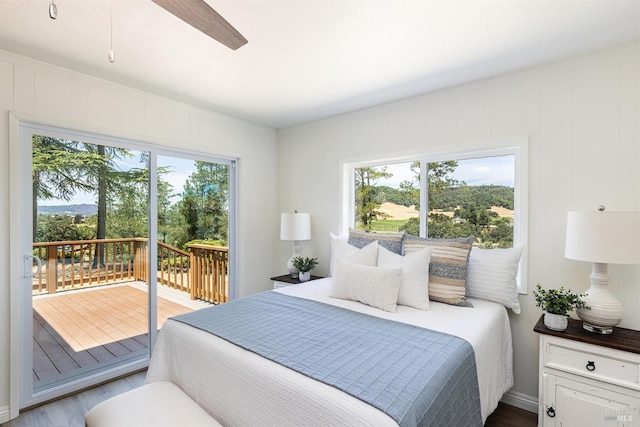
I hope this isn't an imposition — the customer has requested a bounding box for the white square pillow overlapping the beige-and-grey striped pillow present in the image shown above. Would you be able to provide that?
[378,246,432,310]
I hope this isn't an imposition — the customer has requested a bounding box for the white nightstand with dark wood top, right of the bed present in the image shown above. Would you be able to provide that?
[533,315,640,427]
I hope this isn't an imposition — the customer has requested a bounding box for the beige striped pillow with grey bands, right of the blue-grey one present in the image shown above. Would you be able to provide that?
[404,234,475,307]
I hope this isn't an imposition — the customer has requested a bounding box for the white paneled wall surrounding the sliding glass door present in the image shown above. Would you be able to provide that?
[0,51,279,422]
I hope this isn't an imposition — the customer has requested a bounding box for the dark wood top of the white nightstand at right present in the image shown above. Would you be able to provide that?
[533,314,640,354]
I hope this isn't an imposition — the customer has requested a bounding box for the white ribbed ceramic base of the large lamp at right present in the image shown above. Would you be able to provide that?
[576,262,624,335]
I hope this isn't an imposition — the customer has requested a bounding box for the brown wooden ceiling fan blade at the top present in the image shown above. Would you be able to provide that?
[152,0,247,50]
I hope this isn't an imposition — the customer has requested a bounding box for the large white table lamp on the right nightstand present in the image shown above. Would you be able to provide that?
[564,206,640,334]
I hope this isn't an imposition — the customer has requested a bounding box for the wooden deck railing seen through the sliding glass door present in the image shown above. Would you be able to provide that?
[33,238,229,303]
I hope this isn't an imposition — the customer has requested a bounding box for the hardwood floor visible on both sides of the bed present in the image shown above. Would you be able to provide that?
[0,371,538,427]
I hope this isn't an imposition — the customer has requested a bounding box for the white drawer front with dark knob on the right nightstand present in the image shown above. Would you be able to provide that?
[544,340,640,388]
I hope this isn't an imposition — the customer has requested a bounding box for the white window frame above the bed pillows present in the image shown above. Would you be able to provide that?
[338,136,529,294]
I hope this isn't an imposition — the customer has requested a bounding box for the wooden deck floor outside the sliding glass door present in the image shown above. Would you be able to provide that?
[33,283,209,388]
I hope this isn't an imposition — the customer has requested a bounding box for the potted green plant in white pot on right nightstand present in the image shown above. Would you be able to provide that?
[533,283,590,331]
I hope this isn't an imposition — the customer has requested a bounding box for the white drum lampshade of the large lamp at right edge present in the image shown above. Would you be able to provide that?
[564,211,640,264]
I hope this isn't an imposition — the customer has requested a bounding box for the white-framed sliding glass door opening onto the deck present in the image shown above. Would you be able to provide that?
[17,124,234,408]
